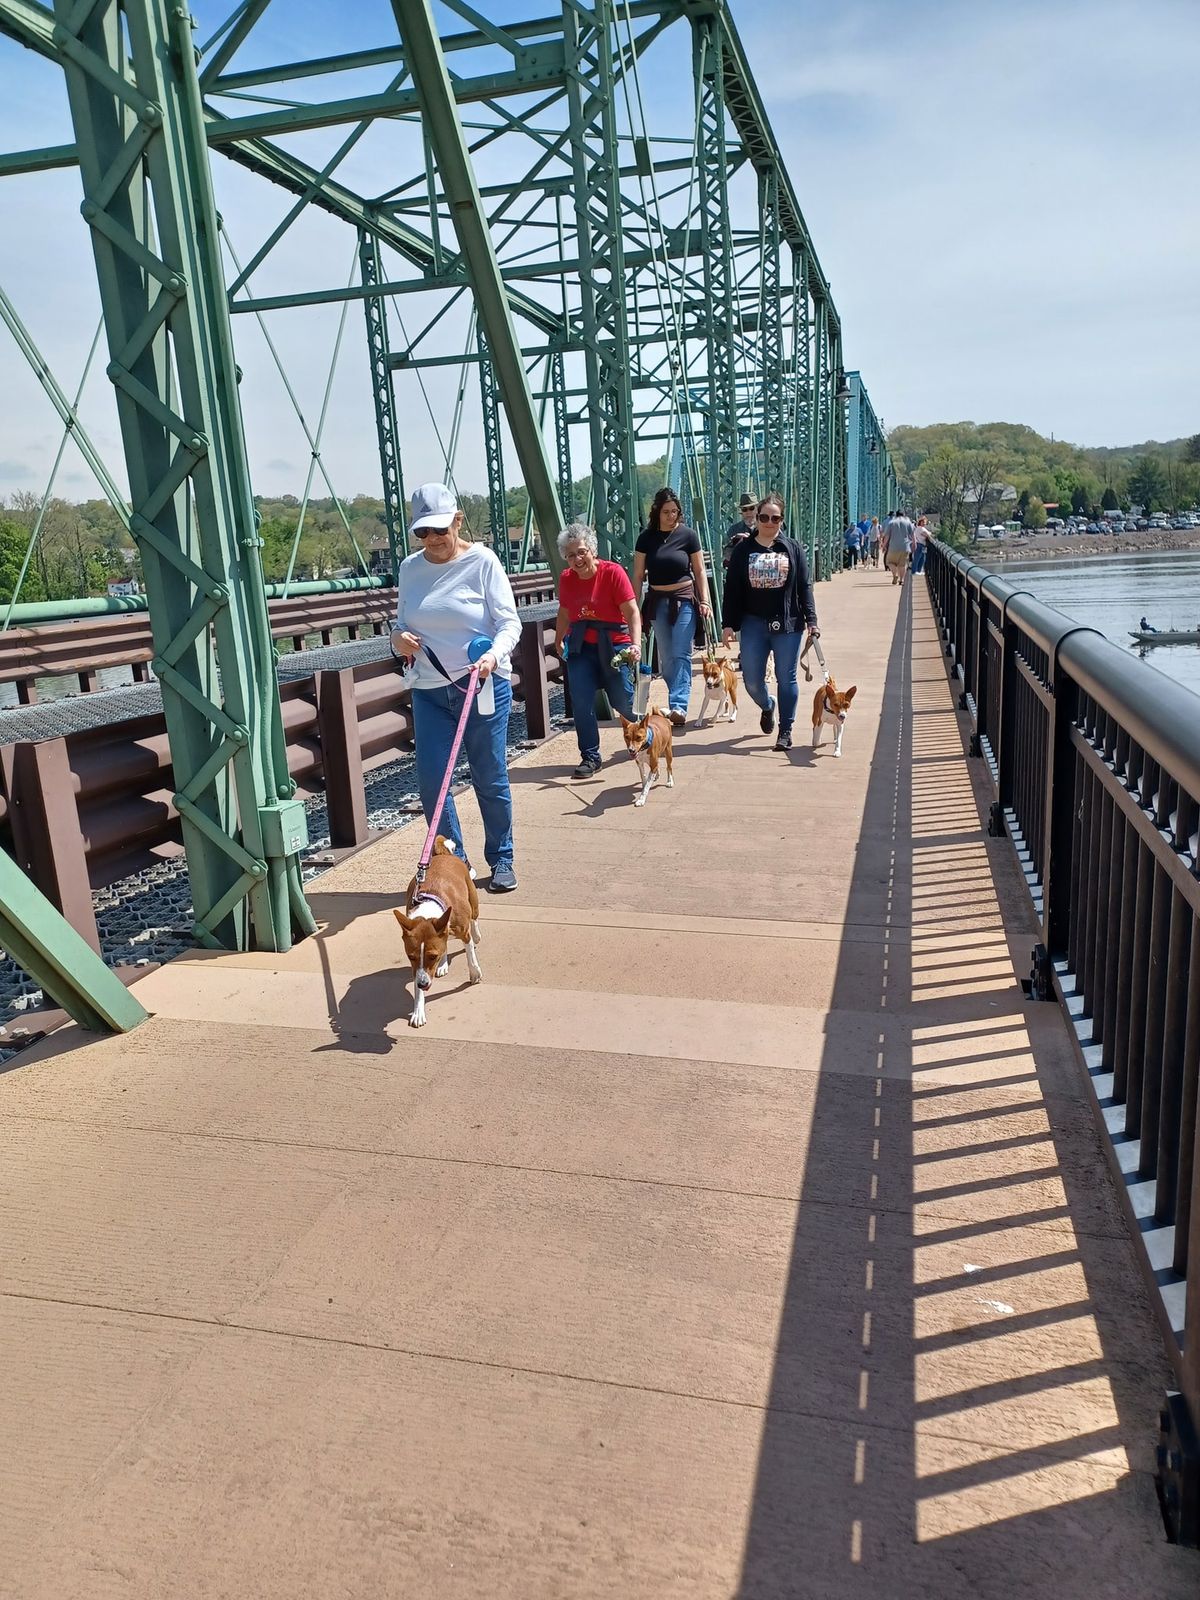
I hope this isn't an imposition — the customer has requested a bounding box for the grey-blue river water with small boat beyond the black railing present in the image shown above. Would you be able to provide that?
[984,550,1200,694]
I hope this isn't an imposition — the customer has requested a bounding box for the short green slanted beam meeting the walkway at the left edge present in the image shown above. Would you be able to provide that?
[0,850,146,1034]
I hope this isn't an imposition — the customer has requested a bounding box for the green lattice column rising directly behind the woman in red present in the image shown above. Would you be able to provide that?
[563,0,638,562]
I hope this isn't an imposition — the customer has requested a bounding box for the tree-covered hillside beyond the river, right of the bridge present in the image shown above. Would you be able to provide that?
[888,422,1200,541]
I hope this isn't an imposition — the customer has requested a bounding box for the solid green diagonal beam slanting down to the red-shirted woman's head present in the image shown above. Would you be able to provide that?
[392,0,562,573]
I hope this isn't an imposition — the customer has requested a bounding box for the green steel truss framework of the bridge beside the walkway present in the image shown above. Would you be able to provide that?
[0,0,894,992]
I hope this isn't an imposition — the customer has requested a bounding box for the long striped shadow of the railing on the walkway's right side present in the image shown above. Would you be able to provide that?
[736,586,1195,1600]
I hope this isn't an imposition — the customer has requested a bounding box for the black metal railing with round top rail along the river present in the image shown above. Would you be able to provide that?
[926,542,1200,1544]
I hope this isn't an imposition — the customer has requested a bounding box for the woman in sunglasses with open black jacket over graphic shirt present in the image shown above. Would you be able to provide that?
[722,494,819,750]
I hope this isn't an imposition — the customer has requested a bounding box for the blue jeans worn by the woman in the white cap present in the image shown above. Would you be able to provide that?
[413,674,512,872]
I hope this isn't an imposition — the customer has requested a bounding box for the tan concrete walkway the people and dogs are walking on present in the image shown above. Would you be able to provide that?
[0,573,1200,1600]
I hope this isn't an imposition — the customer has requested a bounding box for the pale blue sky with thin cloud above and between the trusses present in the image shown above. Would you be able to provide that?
[0,0,1200,498]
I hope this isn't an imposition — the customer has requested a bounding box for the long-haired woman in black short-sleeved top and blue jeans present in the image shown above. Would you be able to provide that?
[634,490,712,728]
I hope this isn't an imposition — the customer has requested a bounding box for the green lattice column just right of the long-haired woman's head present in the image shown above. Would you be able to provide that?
[691,16,741,538]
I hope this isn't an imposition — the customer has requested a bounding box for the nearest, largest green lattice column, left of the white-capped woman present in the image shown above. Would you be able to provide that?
[54,0,314,949]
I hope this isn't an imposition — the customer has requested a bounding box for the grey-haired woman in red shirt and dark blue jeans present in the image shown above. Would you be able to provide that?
[554,522,642,778]
